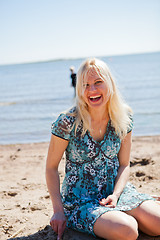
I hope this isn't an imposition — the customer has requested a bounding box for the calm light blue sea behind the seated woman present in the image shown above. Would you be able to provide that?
[0,52,160,144]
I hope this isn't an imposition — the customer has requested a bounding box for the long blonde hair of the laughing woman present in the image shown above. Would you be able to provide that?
[68,58,132,139]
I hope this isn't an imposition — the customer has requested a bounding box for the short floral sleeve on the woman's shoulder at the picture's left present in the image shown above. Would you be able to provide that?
[51,114,74,140]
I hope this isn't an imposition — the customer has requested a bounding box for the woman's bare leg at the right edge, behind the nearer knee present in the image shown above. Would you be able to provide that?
[127,200,160,236]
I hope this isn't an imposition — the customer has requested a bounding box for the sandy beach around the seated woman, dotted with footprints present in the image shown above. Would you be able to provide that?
[0,136,160,240]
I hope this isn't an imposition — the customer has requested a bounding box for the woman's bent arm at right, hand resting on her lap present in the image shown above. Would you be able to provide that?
[100,132,132,207]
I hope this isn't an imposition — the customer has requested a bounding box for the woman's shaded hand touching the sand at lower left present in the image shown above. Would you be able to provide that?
[50,212,66,240]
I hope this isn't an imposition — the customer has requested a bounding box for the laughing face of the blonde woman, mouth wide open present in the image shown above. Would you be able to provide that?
[83,70,109,109]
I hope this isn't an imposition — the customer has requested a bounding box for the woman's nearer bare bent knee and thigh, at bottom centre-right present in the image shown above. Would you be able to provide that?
[94,211,138,240]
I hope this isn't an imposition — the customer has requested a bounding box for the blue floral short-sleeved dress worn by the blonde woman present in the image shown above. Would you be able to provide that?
[52,110,153,236]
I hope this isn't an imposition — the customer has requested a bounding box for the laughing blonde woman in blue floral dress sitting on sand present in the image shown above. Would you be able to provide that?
[46,58,160,240]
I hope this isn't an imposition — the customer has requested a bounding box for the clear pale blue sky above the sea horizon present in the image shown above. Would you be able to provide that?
[0,0,160,64]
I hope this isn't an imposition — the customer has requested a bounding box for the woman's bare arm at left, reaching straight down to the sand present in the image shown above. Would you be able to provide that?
[46,135,68,238]
